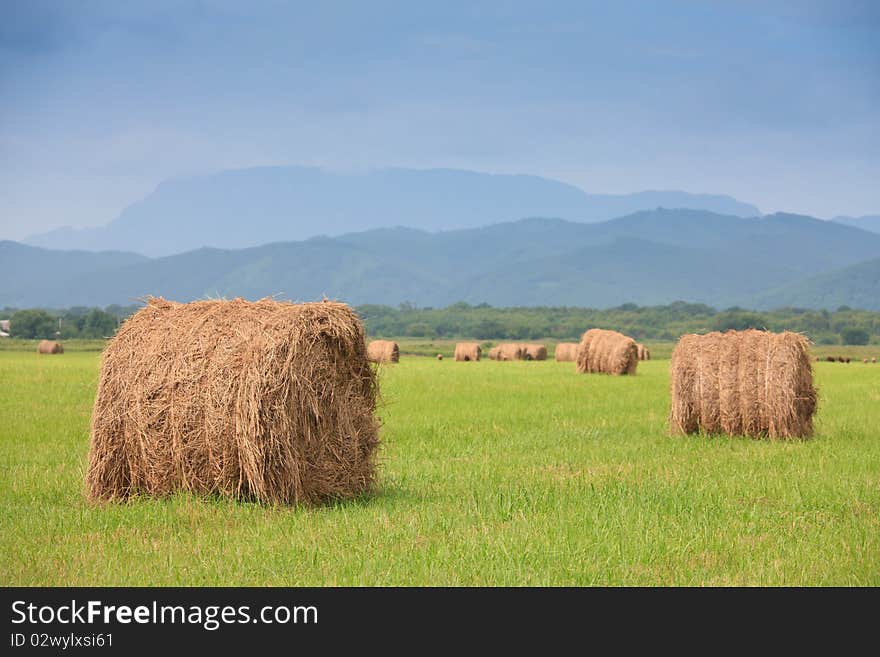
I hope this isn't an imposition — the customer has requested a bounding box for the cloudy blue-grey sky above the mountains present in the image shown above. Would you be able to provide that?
[0,0,880,239]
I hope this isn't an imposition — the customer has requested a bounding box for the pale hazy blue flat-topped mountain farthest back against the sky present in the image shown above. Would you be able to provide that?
[24,167,760,257]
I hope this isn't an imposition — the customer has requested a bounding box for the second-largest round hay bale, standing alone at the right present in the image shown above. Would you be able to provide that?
[669,330,816,438]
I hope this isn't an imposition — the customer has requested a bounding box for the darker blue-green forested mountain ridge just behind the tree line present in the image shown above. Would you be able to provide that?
[6,209,880,310]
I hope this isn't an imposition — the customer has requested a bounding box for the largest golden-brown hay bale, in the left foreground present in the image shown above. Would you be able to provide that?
[86,298,378,504]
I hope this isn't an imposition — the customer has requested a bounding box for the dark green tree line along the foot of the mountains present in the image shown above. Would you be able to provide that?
[0,301,880,345]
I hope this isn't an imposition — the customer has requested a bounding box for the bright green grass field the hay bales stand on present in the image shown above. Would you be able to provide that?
[0,351,880,585]
